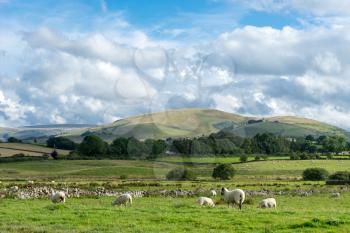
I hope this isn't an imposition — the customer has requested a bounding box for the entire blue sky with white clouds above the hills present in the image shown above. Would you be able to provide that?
[0,0,350,130]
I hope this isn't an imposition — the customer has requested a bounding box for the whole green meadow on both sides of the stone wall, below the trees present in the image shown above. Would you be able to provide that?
[0,157,350,233]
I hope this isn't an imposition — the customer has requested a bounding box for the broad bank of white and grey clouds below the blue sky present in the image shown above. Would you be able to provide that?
[0,10,350,129]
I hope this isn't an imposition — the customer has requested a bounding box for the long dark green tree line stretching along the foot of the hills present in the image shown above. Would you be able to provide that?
[47,131,350,159]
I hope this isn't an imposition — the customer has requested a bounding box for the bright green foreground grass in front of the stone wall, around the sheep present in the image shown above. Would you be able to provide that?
[0,194,350,233]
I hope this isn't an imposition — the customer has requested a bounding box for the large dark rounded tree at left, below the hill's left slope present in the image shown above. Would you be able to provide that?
[78,135,107,157]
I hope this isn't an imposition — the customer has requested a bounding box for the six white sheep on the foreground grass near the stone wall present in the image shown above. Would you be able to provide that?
[50,188,284,209]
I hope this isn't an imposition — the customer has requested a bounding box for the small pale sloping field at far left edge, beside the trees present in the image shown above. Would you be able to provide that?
[0,143,69,157]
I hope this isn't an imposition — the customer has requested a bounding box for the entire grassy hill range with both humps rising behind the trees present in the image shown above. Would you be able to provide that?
[66,109,350,141]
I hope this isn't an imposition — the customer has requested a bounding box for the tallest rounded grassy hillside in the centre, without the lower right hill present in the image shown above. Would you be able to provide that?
[65,109,249,140]
